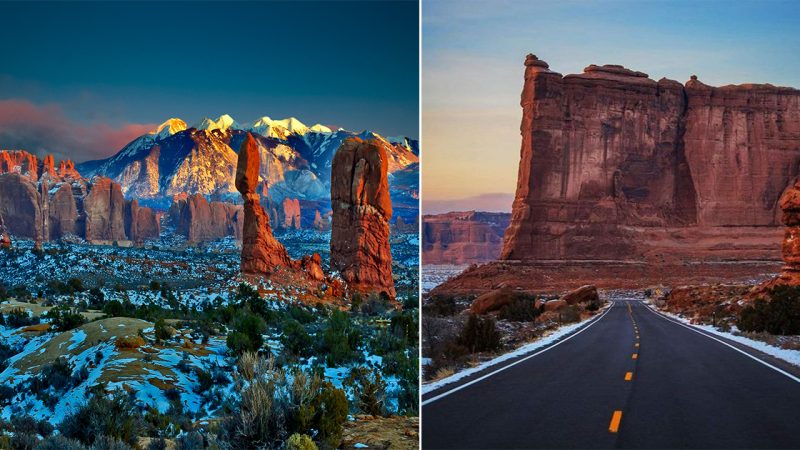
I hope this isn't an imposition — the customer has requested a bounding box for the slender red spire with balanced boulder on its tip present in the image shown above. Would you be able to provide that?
[236,133,292,275]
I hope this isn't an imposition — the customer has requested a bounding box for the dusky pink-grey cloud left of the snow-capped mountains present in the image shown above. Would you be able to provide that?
[0,99,156,162]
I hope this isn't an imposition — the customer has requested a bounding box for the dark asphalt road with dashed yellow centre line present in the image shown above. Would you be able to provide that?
[422,300,800,449]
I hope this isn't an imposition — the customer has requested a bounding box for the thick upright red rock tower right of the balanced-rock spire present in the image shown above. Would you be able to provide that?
[331,138,396,298]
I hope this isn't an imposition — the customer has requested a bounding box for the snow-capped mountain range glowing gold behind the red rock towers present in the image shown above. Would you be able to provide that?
[76,114,419,206]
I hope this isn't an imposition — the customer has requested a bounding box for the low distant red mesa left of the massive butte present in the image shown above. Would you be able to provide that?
[422,211,511,264]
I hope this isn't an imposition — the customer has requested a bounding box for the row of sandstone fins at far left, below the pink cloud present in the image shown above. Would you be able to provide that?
[0,150,160,243]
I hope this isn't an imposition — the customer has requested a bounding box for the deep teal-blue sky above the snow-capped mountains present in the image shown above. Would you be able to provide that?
[0,1,419,159]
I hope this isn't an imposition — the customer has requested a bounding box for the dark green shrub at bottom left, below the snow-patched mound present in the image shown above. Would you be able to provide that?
[58,393,145,449]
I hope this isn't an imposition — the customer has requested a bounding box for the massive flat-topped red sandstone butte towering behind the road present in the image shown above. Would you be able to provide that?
[501,55,800,261]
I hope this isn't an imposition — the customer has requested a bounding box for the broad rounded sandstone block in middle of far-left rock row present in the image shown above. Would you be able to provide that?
[83,177,126,241]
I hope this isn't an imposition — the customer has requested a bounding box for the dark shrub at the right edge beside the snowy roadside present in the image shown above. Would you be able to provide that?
[736,286,800,335]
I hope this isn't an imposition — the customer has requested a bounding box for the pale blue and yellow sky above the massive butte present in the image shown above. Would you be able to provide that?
[422,0,800,210]
